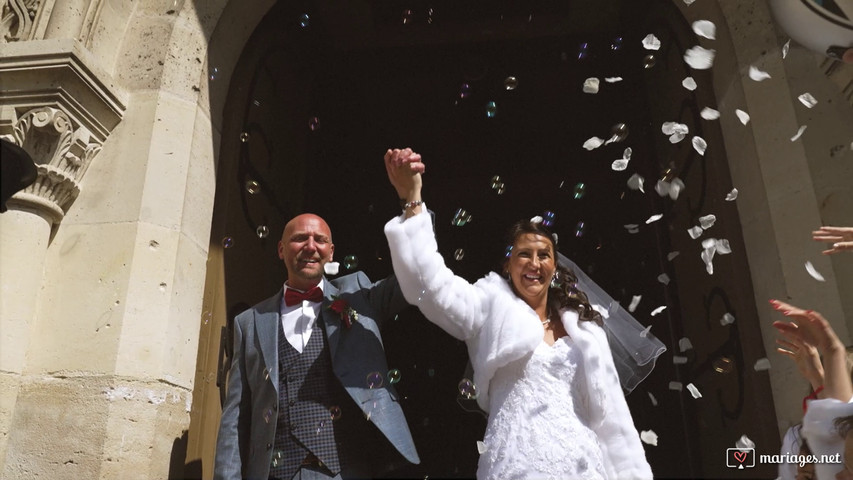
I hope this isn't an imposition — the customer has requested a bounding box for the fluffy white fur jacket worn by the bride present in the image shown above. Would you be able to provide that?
[385,207,652,479]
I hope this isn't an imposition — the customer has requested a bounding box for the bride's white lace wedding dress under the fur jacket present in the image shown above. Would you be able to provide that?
[477,337,606,480]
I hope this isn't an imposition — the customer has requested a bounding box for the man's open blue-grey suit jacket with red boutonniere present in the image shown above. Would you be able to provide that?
[214,272,420,480]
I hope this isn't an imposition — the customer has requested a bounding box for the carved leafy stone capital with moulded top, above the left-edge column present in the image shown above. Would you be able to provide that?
[0,41,126,224]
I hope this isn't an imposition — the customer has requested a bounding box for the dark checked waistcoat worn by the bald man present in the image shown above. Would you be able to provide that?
[270,319,368,479]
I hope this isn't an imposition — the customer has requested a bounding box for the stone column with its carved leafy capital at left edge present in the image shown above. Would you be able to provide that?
[0,40,124,468]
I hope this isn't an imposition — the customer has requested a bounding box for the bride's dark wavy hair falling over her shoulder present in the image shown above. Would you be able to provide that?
[503,220,603,325]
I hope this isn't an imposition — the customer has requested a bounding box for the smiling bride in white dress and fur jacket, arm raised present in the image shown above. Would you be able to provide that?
[385,149,662,480]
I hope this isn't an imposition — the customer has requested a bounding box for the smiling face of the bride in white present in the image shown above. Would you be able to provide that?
[506,233,557,309]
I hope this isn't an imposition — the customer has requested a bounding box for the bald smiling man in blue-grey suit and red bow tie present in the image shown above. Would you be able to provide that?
[214,214,420,480]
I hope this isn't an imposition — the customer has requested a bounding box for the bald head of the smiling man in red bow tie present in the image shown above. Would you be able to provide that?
[278,214,335,290]
